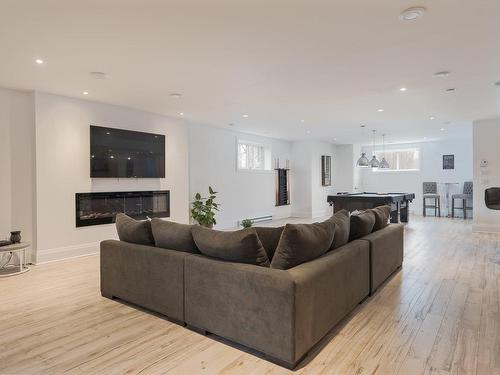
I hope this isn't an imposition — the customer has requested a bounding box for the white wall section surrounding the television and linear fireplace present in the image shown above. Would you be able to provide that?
[35,93,189,262]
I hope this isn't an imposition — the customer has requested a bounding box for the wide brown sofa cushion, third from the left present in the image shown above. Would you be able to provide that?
[192,225,269,267]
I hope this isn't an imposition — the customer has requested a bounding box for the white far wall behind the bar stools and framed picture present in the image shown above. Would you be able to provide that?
[356,137,472,215]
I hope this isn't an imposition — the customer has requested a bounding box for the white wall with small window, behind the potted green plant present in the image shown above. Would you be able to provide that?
[189,124,294,228]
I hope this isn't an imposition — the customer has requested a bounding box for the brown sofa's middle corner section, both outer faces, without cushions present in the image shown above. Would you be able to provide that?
[185,241,369,368]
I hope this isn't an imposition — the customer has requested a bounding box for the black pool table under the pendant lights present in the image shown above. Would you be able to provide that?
[327,192,415,223]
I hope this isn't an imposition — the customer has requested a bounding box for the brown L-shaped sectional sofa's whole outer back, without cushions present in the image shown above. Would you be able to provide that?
[101,224,403,368]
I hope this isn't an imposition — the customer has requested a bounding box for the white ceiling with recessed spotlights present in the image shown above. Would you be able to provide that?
[0,0,500,143]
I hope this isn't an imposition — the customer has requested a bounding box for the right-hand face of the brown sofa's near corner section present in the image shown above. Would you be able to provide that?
[288,240,370,358]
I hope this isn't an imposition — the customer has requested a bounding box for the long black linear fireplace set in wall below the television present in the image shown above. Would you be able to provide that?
[75,190,170,227]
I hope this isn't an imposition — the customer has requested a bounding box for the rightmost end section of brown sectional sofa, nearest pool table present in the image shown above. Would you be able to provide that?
[361,224,404,294]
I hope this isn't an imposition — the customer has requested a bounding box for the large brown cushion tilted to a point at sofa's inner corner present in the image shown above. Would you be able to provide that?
[271,220,335,270]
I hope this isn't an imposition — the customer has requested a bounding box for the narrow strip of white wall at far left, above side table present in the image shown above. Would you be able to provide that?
[0,89,36,262]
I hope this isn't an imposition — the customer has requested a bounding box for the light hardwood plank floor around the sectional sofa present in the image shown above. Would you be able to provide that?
[0,217,500,374]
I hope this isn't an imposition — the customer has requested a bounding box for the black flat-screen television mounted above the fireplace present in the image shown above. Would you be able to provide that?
[90,125,165,178]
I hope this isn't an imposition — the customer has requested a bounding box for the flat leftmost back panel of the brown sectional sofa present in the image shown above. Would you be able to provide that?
[101,240,189,322]
